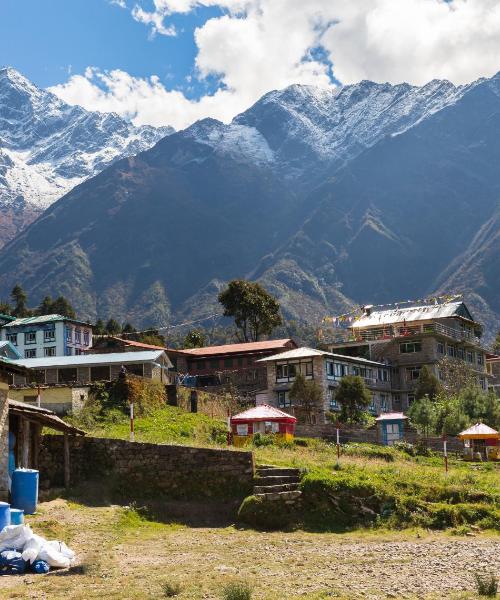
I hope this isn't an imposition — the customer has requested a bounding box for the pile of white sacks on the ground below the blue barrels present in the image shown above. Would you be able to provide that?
[0,525,75,568]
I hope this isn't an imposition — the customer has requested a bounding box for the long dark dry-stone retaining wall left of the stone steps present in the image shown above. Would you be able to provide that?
[39,435,254,500]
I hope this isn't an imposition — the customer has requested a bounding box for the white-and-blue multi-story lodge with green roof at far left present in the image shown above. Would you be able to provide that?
[0,315,92,358]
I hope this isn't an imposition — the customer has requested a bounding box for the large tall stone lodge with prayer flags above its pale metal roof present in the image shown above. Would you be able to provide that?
[331,302,488,411]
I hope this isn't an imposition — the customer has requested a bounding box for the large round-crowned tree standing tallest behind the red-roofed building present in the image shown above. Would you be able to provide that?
[219,279,282,342]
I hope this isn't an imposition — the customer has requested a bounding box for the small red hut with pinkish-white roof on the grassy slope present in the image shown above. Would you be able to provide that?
[231,404,297,446]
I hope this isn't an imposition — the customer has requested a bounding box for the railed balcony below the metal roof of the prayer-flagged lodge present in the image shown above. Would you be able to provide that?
[344,323,480,346]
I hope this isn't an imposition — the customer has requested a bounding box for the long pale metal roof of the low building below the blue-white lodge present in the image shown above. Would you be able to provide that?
[12,350,172,369]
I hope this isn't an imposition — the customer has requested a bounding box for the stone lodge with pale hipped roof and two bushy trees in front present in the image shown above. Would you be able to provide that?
[257,348,392,423]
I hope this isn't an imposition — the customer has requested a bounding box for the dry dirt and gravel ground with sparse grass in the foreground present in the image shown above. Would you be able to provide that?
[0,500,500,600]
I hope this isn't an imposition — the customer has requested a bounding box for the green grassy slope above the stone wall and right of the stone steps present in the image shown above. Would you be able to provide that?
[68,407,500,535]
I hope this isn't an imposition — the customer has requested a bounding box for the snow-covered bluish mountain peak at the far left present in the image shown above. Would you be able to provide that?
[0,67,173,245]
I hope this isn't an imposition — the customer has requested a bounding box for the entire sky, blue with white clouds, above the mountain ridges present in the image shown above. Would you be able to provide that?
[0,0,500,129]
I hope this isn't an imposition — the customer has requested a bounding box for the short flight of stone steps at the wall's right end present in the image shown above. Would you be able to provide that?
[253,465,302,503]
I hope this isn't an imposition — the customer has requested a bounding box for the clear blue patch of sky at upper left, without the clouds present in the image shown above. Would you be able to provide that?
[0,0,221,97]
